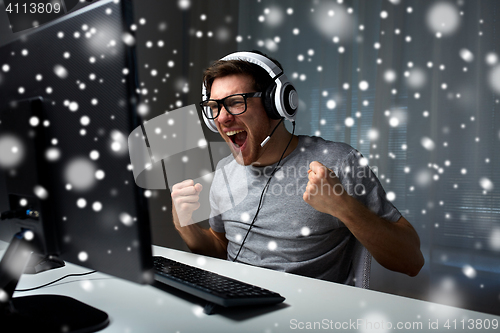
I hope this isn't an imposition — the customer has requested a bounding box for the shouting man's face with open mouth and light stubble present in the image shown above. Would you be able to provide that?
[210,74,272,165]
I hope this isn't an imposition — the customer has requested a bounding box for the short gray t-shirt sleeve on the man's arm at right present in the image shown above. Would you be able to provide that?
[336,149,401,222]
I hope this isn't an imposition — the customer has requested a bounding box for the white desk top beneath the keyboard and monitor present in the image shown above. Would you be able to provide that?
[0,242,500,333]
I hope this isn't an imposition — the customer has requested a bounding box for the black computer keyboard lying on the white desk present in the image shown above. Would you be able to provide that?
[153,256,285,314]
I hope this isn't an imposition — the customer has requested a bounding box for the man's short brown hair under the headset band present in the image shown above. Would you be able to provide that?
[203,50,283,97]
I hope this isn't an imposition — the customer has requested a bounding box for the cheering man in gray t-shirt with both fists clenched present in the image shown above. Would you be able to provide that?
[172,51,424,284]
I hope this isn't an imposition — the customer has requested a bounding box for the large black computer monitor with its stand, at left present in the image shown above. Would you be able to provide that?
[0,0,153,331]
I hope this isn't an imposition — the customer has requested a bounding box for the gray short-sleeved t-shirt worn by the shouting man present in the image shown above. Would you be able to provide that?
[209,136,401,284]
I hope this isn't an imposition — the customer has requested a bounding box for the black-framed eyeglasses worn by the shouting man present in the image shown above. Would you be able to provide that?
[200,92,262,119]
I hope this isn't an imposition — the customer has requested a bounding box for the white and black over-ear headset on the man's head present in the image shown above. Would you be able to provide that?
[202,52,299,133]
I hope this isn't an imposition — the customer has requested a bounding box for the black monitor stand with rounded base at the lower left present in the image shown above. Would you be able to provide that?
[0,230,109,332]
